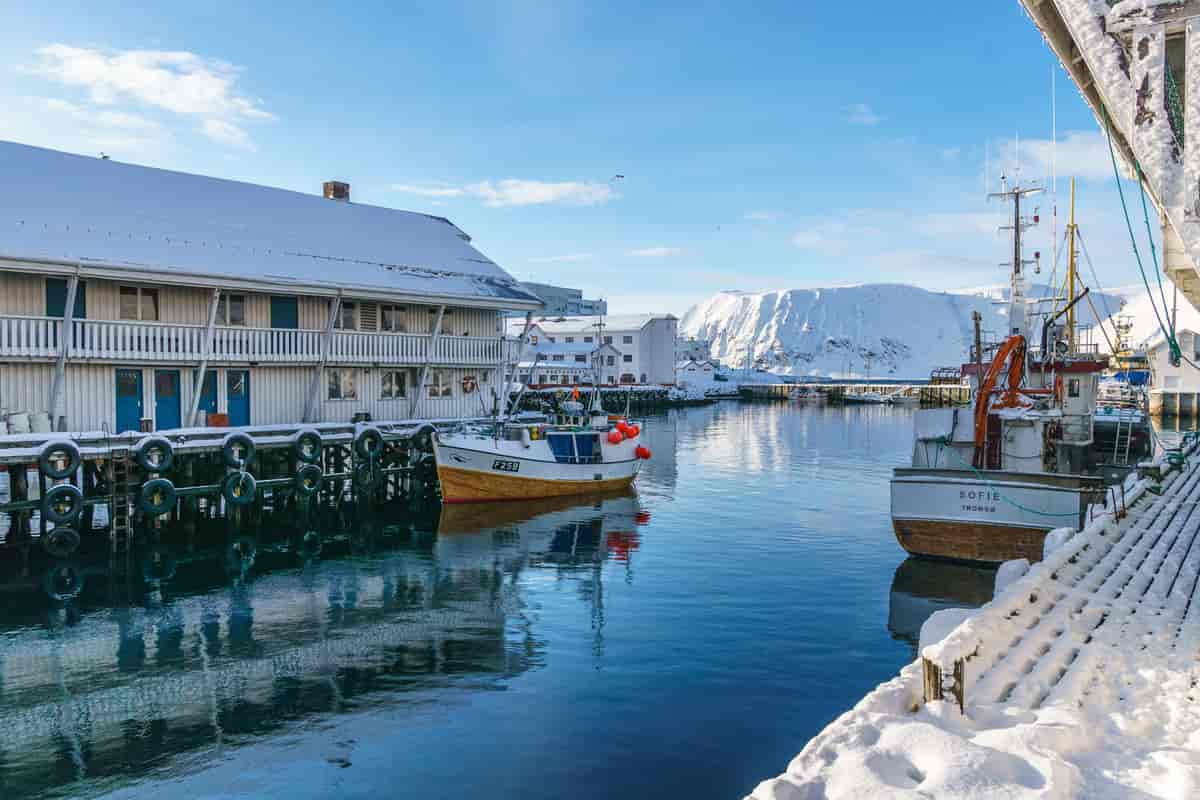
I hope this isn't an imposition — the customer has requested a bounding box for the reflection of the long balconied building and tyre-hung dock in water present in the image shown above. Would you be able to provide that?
[0,494,646,799]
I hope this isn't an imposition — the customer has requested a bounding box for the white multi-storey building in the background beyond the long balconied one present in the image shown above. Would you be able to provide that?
[509,314,679,386]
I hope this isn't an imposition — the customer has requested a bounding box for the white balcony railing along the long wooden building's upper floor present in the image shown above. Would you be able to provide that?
[0,315,500,366]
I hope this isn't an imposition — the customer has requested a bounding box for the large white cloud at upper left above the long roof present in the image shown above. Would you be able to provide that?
[25,43,275,149]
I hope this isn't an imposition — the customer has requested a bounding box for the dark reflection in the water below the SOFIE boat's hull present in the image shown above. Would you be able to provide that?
[888,557,996,657]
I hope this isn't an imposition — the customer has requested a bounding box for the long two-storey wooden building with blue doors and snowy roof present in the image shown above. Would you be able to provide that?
[0,142,540,432]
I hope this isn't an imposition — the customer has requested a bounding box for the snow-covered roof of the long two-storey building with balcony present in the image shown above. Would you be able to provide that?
[0,142,541,308]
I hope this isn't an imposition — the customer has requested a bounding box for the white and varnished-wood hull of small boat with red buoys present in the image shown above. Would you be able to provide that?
[436,441,641,503]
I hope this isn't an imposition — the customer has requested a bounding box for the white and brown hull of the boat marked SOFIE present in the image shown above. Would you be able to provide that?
[892,469,1104,564]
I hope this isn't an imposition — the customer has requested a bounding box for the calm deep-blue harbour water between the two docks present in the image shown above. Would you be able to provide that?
[0,403,992,799]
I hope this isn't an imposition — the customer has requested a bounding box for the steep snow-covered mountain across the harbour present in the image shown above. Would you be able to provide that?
[679,283,1122,379]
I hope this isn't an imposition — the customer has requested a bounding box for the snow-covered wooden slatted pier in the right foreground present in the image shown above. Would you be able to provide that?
[752,434,1200,800]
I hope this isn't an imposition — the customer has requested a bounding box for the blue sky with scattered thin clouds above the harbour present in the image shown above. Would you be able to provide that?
[0,0,1138,313]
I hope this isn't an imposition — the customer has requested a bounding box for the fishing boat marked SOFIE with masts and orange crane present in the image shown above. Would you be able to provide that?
[892,176,1108,563]
